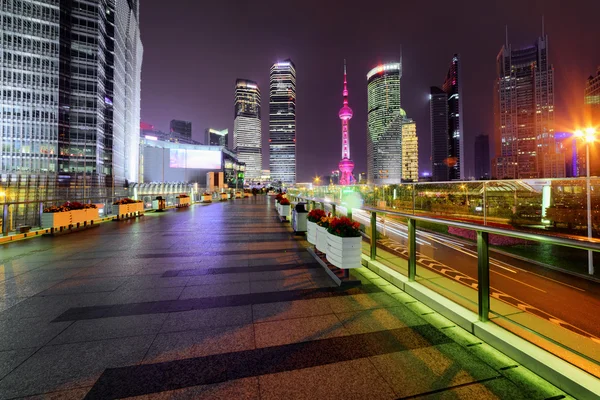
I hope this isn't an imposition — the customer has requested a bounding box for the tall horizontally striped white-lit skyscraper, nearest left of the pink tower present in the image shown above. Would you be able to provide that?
[269,59,296,185]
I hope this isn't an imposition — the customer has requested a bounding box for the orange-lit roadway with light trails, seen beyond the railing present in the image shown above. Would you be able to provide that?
[353,210,600,344]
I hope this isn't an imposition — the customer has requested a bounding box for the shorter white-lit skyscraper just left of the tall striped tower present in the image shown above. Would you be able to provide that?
[233,79,262,179]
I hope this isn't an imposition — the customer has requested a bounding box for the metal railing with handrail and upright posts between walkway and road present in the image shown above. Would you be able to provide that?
[288,191,600,376]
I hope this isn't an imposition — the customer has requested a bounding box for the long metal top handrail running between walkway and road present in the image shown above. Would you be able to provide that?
[293,195,600,252]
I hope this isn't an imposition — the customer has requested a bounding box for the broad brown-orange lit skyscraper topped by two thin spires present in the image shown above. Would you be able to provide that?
[492,32,565,179]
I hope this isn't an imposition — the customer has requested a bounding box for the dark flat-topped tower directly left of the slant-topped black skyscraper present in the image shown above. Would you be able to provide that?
[429,86,450,182]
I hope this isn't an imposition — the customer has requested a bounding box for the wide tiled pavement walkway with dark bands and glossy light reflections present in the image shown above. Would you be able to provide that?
[0,197,565,399]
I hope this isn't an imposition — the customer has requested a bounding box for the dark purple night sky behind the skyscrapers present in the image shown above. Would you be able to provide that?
[140,0,600,182]
